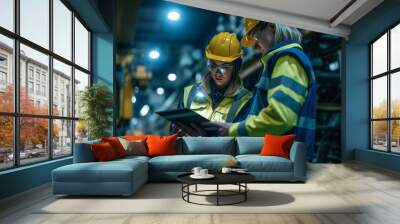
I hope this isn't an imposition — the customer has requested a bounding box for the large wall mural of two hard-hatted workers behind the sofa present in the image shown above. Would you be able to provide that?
[115,1,342,162]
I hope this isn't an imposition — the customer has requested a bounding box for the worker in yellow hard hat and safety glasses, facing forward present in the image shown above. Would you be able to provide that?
[172,32,251,136]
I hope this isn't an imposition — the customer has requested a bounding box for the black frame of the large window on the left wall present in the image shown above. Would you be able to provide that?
[0,0,93,172]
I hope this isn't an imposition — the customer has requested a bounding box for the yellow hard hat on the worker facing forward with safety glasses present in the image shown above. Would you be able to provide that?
[206,32,243,62]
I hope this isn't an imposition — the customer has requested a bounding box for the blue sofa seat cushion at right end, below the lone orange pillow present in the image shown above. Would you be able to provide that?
[236,155,293,172]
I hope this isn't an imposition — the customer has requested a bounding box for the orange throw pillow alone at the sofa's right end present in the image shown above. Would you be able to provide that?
[260,135,296,159]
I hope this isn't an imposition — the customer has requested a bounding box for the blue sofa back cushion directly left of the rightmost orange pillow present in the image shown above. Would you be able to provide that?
[236,137,264,155]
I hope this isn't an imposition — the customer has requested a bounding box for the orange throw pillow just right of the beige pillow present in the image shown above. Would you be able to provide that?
[146,135,177,157]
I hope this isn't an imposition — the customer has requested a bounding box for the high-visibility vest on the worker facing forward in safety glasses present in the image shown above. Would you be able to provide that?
[183,83,251,122]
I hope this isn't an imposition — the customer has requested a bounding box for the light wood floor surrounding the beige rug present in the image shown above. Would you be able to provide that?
[0,163,400,224]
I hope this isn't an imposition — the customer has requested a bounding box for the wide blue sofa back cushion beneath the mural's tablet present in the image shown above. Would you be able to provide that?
[178,137,235,155]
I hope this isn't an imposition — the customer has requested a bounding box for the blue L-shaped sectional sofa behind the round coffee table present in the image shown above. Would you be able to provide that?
[52,137,306,195]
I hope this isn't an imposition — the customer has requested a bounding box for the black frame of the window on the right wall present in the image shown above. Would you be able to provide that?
[368,20,400,155]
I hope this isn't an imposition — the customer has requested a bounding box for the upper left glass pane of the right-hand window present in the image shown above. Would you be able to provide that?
[372,34,387,76]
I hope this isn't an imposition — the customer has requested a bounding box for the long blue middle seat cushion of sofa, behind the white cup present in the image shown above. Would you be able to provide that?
[149,154,235,172]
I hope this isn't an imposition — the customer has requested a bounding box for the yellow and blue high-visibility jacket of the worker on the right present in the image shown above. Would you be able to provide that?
[229,41,316,161]
